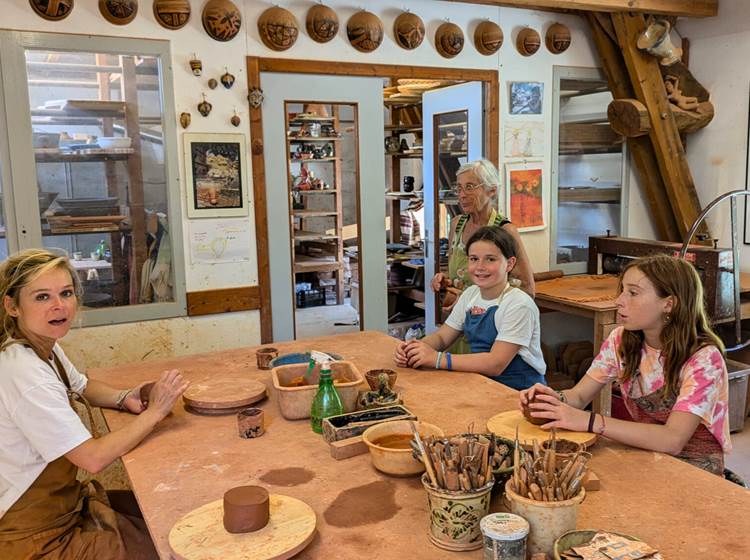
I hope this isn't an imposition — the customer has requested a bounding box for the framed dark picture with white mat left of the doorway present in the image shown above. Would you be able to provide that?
[182,133,248,218]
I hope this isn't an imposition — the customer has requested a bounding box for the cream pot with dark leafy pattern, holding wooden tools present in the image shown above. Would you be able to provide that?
[422,473,495,551]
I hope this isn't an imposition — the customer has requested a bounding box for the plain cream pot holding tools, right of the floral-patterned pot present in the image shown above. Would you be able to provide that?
[505,480,586,556]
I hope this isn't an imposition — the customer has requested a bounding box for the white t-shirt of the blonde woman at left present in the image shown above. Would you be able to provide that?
[0,344,91,517]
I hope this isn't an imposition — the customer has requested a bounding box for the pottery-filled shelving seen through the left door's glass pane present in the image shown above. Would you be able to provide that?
[286,105,345,305]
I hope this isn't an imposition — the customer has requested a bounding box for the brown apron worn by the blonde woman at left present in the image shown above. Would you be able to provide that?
[0,356,158,560]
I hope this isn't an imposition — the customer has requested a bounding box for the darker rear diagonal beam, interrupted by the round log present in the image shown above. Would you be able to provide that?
[586,14,682,241]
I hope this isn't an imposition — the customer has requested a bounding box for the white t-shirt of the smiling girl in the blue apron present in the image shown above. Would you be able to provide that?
[445,285,547,375]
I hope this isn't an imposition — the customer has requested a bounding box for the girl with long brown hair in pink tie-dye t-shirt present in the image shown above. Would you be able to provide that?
[519,255,731,475]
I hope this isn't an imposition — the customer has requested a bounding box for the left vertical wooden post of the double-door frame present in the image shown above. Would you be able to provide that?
[247,56,273,344]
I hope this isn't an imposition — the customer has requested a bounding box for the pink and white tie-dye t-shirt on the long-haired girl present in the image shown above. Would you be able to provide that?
[586,327,732,453]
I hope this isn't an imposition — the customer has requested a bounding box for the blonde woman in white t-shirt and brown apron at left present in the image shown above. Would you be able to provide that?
[0,249,187,560]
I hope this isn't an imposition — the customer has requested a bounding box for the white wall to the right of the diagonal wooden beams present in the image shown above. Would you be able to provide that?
[677,0,750,271]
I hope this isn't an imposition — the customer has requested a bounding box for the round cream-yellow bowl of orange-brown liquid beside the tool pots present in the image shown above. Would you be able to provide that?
[362,420,445,476]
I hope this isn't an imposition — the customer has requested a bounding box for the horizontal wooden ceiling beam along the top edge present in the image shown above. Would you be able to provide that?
[445,0,719,17]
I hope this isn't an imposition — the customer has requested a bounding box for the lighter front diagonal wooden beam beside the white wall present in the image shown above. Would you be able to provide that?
[612,13,708,240]
